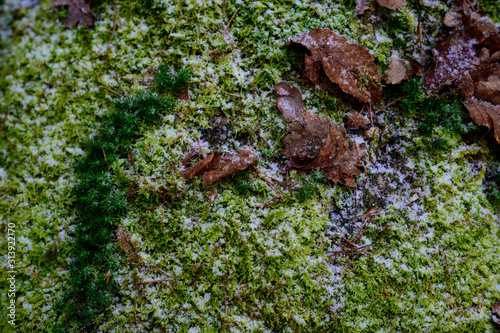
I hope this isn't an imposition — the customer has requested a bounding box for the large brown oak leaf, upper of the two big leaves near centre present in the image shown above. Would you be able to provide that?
[286,29,382,103]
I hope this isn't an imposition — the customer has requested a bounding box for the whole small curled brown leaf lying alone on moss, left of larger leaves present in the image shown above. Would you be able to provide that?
[181,149,259,185]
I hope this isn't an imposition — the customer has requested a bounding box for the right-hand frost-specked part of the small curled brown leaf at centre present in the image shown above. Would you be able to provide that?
[203,149,259,185]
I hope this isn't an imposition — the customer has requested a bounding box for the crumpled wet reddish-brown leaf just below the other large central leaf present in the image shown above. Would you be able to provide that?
[274,82,366,187]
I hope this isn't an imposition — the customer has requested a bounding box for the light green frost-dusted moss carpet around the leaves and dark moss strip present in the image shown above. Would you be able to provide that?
[0,0,500,332]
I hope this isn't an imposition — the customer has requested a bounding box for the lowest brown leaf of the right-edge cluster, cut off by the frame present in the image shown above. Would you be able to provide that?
[465,97,500,143]
